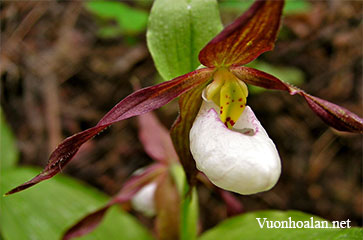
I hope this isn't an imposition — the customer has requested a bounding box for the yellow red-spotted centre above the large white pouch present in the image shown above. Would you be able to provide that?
[206,68,248,128]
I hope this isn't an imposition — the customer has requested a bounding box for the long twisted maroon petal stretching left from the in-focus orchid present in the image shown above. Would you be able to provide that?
[6,68,213,195]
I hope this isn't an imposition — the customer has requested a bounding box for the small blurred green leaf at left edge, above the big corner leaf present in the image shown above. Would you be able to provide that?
[0,108,19,172]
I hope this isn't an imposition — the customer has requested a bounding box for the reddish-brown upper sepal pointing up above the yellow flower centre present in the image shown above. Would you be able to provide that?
[199,0,284,67]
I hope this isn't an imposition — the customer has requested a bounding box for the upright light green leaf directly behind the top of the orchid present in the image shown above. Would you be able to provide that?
[147,0,222,80]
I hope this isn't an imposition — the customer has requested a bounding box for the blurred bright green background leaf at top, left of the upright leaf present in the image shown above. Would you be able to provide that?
[85,1,148,34]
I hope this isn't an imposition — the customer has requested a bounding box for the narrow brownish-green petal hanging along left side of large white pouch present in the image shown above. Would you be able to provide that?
[170,81,209,186]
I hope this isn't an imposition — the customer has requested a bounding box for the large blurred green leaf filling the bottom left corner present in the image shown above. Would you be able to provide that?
[0,168,152,240]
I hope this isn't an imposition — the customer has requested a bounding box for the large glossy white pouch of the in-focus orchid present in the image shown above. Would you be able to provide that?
[189,101,281,195]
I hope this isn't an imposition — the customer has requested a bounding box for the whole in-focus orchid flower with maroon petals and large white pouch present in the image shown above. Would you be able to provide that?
[7,0,363,200]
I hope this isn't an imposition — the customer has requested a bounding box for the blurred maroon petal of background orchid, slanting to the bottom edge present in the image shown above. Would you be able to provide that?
[63,164,166,240]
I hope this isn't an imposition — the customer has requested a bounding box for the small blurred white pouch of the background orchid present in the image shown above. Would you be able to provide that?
[131,182,157,217]
